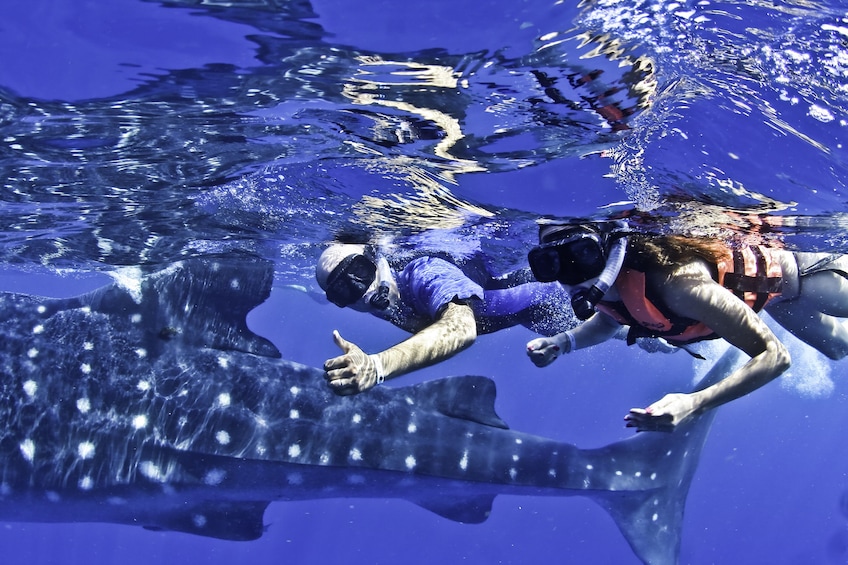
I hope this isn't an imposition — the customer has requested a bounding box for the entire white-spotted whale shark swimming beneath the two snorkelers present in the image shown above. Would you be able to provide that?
[0,258,729,563]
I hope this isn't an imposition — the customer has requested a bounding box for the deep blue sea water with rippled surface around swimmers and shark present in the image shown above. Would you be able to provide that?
[0,0,848,564]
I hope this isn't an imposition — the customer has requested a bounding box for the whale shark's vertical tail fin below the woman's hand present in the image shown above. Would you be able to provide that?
[592,348,741,565]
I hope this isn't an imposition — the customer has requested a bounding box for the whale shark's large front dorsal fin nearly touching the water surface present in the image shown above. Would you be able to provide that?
[82,256,280,357]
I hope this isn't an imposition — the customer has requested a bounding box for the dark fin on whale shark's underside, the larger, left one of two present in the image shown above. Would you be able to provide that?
[144,502,270,541]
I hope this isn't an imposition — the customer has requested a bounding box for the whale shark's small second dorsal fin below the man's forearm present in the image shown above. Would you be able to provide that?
[414,376,509,430]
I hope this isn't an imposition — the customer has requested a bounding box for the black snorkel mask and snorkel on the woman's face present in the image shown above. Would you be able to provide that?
[527,223,627,320]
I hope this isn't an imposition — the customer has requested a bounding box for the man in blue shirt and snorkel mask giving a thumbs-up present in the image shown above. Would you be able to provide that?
[315,244,574,394]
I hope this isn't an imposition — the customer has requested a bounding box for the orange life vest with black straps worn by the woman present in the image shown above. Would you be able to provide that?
[598,246,783,344]
